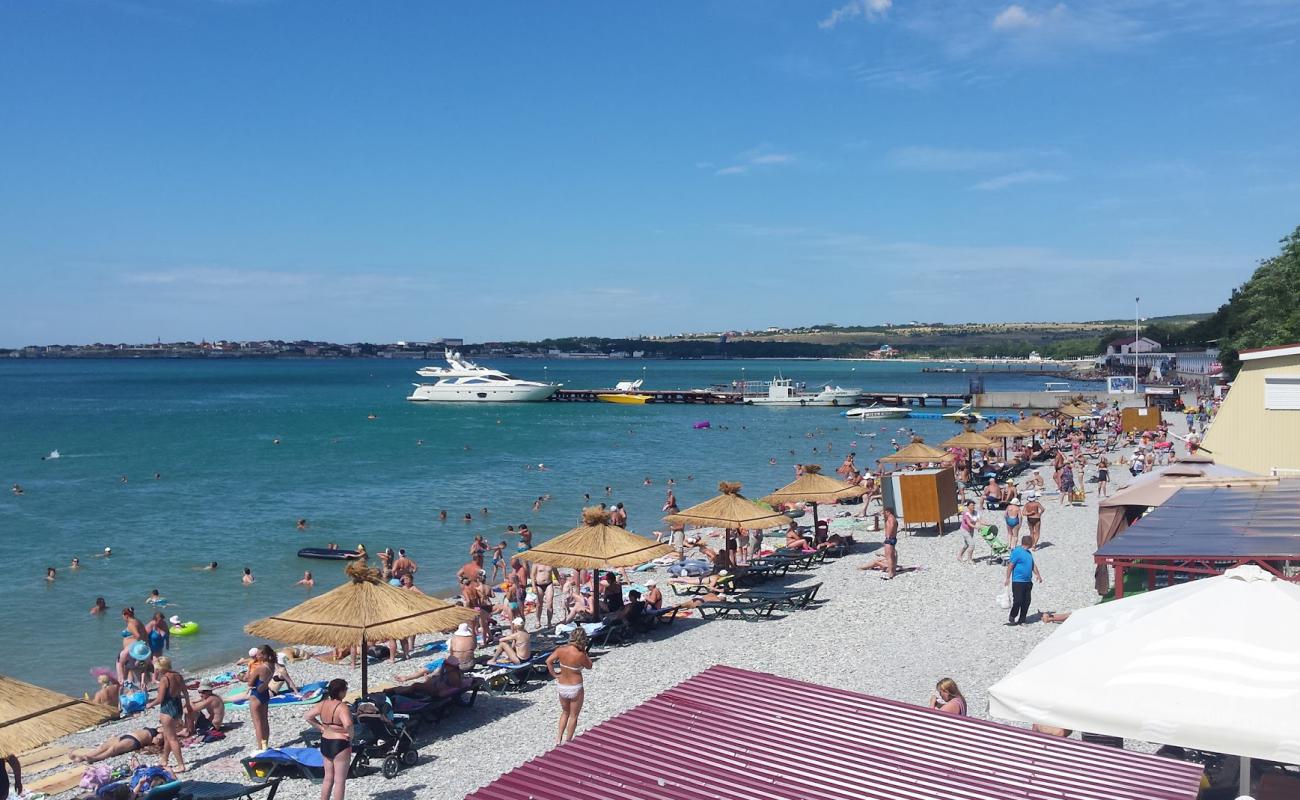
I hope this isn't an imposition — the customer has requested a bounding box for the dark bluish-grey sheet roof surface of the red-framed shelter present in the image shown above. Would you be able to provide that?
[1096,480,1300,558]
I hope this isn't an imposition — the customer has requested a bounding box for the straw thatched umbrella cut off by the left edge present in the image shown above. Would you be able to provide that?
[0,675,113,769]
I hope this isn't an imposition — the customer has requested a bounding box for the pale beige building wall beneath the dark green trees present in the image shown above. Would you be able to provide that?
[1203,355,1300,475]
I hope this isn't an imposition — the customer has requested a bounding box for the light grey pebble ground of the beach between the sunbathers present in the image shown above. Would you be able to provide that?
[43,415,1177,800]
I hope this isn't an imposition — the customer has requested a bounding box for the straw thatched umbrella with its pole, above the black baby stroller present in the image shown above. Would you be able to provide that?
[244,562,478,697]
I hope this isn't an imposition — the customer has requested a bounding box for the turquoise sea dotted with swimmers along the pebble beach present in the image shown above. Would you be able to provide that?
[0,359,1081,695]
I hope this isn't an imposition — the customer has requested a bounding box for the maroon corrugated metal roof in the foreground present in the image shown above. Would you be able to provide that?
[468,666,1200,800]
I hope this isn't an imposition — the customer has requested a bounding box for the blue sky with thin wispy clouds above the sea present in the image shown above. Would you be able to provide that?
[0,0,1300,346]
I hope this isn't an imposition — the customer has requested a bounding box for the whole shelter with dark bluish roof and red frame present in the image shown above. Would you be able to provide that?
[1093,476,1300,597]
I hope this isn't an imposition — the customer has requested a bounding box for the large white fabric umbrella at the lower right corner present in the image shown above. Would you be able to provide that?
[988,566,1300,795]
